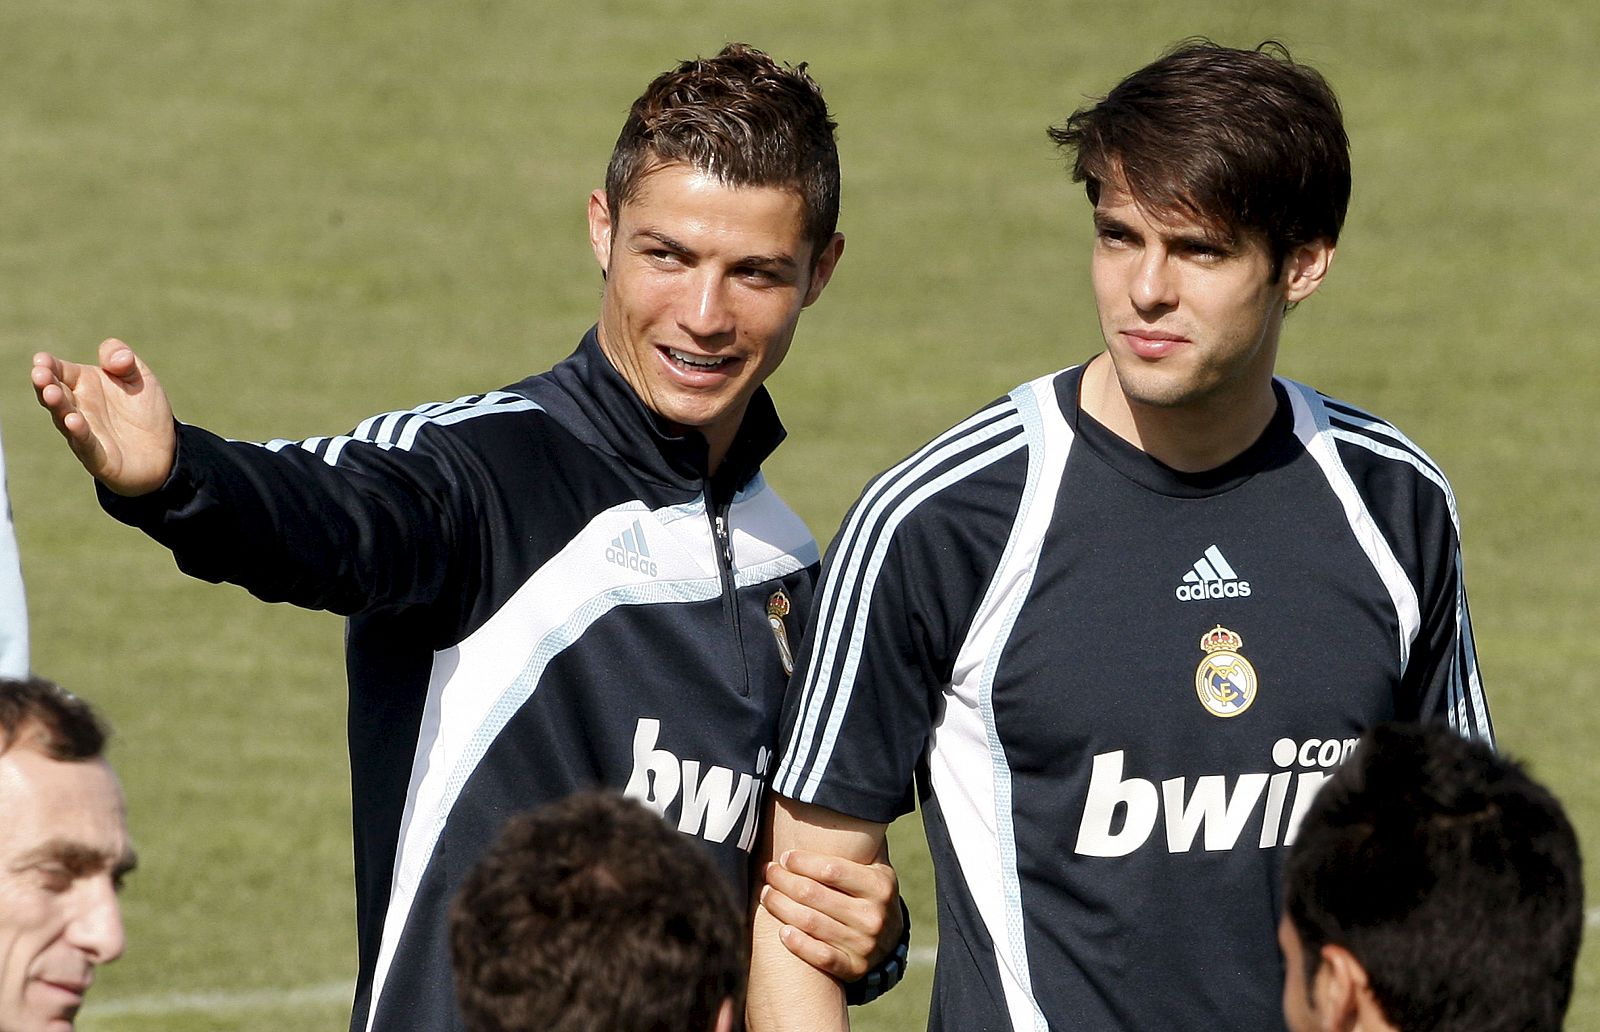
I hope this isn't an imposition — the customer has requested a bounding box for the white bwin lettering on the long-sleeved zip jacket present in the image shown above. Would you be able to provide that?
[622,717,771,853]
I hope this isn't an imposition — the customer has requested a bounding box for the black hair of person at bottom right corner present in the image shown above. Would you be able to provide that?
[1283,725,1584,1032]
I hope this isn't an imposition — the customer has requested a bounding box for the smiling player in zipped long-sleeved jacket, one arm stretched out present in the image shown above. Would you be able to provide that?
[32,45,899,1032]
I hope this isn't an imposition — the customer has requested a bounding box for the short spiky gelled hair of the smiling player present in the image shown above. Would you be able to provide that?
[605,43,838,261]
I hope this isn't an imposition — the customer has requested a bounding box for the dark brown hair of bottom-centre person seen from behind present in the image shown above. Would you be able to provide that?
[450,792,746,1032]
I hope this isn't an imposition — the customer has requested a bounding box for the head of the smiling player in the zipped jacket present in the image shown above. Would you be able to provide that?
[589,43,845,467]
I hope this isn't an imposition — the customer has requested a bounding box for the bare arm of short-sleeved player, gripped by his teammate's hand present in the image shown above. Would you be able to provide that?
[746,798,885,1032]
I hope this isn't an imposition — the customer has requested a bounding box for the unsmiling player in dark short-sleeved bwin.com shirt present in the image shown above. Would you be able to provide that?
[750,42,1491,1032]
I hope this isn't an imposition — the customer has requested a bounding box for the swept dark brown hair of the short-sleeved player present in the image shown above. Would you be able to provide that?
[1050,38,1350,270]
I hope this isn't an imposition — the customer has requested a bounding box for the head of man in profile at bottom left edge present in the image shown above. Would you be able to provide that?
[0,677,134,1032]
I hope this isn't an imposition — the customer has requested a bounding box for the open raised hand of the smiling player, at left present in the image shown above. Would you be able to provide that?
[32,339,178,496]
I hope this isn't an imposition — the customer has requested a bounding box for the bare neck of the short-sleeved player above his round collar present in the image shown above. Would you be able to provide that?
[1078,354,1277,474]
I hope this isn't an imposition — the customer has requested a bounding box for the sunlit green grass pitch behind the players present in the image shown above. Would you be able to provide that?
[0,0,1600,1032]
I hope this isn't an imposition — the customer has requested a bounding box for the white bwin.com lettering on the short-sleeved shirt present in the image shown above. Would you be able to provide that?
[1075,738,1355,856]
